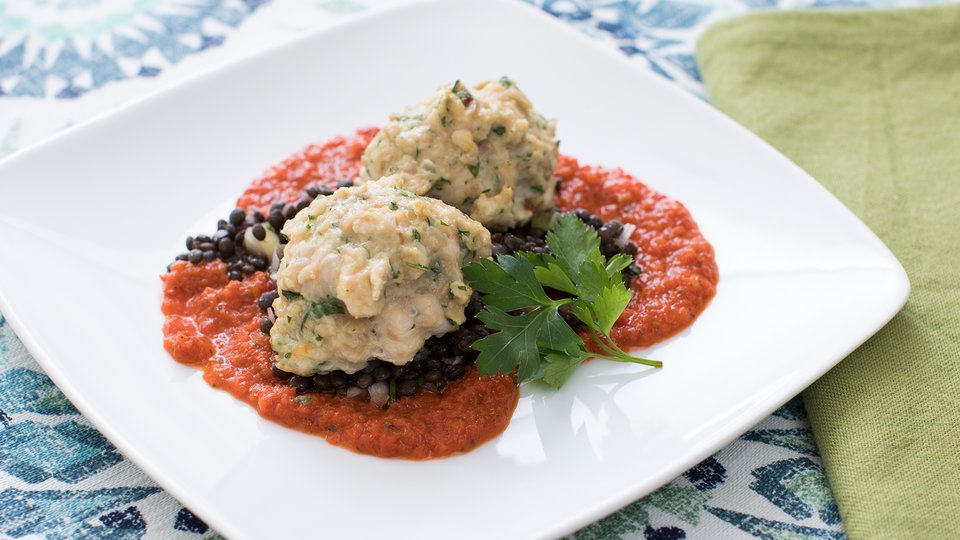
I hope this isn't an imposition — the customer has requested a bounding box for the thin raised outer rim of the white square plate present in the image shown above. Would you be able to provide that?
[0,0,910,539]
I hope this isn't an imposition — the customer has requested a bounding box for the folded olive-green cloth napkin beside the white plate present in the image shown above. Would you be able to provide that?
[697,5,960,539]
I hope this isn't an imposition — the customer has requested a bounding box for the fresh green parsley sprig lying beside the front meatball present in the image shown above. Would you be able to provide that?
[463,214,663,388]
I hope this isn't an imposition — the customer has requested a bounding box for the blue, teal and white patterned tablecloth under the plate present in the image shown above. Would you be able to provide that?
[0,0,944,540]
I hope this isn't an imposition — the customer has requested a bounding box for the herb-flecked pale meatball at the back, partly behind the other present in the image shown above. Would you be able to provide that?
[358,78,557,229]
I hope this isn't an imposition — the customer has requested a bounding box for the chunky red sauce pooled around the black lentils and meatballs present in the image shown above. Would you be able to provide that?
[162,128,718,459]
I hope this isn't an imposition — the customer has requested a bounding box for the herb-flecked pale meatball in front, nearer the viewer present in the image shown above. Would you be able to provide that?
[270,178,491,375]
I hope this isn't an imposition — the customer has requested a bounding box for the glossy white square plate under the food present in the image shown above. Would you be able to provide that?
[0,0,909,539]
